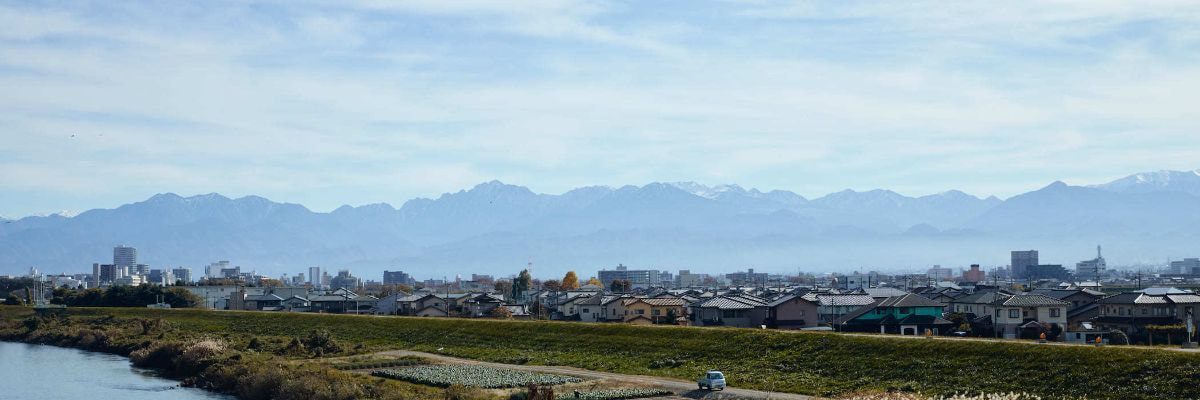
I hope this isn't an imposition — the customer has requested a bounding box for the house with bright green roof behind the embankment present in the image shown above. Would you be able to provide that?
[835,293,954,335]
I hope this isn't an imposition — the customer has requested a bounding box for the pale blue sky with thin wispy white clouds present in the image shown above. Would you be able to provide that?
[0,0,1200,217]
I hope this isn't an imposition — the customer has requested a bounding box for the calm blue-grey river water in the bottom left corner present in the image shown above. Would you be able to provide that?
[0,341,234,400]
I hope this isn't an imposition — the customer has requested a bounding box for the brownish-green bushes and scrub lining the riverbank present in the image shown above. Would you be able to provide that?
[0,308,472,400]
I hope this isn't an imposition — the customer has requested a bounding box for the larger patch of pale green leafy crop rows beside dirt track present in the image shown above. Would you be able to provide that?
[371,365,583,389]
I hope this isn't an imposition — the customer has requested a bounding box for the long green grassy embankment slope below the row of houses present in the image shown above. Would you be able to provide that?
[7,303,1200,399]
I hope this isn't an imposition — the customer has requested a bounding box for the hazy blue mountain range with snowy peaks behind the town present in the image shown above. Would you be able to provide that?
[0,166,1200,279]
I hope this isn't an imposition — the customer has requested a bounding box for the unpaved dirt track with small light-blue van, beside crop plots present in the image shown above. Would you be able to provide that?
[376,350,820,400]
